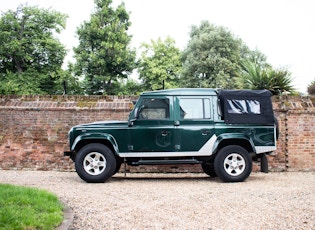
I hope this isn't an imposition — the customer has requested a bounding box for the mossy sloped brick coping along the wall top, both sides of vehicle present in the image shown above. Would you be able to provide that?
[0,95,315,112]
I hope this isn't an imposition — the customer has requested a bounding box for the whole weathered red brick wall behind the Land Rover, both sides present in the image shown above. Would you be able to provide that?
[0,96,315,172]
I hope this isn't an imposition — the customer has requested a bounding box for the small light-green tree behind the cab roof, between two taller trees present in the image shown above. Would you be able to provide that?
[138,37,182,90]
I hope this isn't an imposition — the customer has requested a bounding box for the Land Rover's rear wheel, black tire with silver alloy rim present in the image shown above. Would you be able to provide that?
[214,145,252,182]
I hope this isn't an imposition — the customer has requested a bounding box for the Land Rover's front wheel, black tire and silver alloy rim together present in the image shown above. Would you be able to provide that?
[75,143,116,183]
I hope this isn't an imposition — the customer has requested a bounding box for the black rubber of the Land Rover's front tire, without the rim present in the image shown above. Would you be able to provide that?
[75,143,116,183]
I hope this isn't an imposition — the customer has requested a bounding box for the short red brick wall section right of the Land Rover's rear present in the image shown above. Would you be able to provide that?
[269,96,315,171]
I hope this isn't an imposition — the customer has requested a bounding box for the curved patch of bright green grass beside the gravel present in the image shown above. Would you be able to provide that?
[0,184,63,230]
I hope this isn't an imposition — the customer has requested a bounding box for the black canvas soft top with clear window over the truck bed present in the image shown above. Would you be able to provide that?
[218,90,275,124]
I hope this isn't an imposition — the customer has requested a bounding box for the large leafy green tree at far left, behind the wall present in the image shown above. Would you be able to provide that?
[0,5,67,94]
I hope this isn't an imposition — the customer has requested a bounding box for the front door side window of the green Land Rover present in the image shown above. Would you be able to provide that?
[139,98,170,120]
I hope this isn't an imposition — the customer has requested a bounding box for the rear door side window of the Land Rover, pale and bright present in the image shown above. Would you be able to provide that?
[179,98,211,119]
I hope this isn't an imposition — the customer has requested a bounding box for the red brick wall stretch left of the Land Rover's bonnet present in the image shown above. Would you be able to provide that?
[0,96,132,170]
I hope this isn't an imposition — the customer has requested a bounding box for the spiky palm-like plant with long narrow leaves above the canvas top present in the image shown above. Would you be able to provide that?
[241,61,295,95]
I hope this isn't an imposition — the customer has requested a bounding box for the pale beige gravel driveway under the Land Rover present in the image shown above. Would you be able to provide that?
[0,170,315,230]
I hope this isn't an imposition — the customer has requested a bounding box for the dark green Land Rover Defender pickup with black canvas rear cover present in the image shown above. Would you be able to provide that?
[64,88,278,183]
